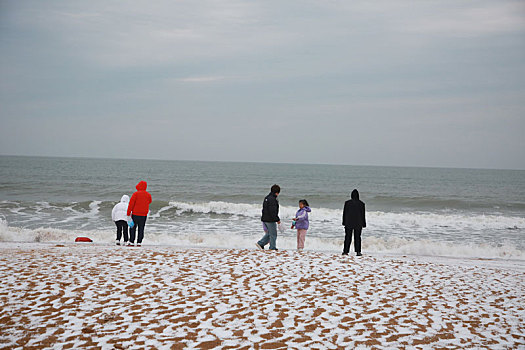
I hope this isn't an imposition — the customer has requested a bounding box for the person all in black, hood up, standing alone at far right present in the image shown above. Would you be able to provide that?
[343,190,366,256]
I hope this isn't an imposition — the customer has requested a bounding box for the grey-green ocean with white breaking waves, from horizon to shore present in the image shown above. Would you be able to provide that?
[0,156,525,260]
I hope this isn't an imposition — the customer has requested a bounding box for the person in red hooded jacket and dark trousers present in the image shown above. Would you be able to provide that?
[127,181,151,247]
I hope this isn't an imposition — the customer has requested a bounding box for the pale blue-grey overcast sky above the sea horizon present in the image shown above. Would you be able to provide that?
[0,0,525,169]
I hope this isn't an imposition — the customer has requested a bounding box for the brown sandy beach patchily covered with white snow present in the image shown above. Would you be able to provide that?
[0,243,525,349]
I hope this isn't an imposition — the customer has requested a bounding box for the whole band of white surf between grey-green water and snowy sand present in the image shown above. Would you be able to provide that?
[4,201,525,260]
